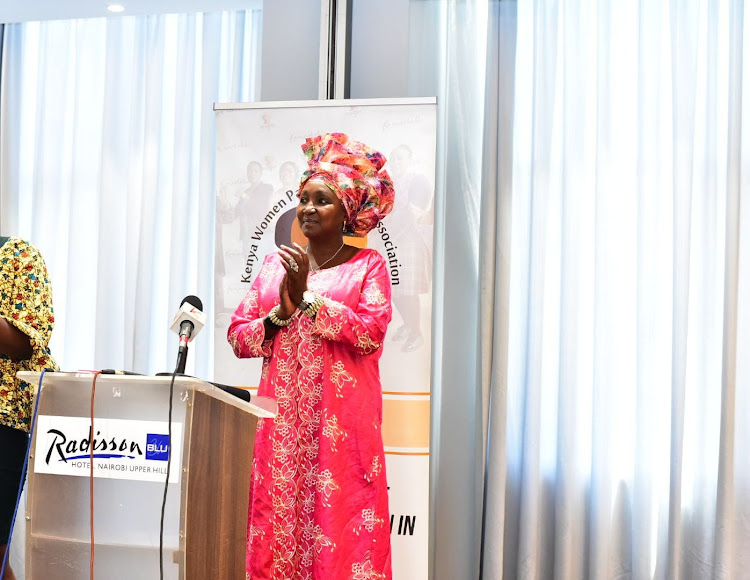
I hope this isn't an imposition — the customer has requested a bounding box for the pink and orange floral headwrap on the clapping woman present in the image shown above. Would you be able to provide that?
[297,133,394,237]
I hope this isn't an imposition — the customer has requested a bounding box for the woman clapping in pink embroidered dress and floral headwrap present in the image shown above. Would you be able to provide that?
[228,133,394,580]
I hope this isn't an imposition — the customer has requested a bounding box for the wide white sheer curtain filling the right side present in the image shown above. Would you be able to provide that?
[482,0,750,580]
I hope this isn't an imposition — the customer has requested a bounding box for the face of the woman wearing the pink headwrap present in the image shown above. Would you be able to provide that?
[297,179,346,238]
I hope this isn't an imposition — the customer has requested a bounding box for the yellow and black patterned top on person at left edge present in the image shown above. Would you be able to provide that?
[0,238,57,431]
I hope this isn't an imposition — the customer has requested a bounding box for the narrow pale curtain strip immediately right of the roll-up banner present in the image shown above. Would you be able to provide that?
[409,0,487,580]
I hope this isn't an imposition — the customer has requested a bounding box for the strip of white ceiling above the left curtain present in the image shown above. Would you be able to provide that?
[0,0,264,23]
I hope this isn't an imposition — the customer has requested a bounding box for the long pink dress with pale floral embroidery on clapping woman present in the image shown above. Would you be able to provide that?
[228,249,391,580]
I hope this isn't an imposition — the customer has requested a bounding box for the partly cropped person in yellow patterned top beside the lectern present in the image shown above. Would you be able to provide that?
[0,237,57,580]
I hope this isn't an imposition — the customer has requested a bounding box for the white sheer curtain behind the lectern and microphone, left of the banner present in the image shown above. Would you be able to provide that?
[0,10,262,378]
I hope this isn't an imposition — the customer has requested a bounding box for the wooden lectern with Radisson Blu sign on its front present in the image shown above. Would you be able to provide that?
[19,372,276,580]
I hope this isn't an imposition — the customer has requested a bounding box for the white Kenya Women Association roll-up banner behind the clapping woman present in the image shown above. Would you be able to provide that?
[214,98,436,580]
